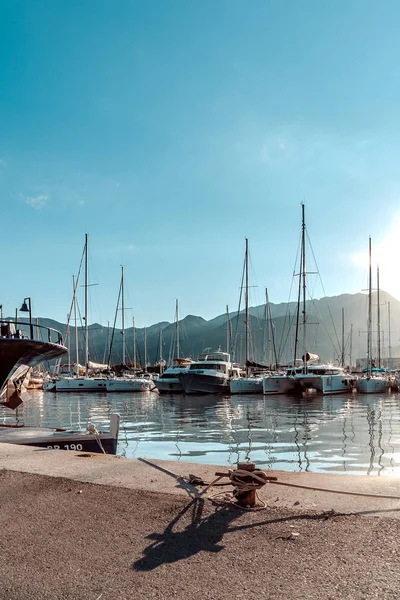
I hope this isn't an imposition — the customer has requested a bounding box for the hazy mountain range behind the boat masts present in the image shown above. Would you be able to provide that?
[10,291,400,365]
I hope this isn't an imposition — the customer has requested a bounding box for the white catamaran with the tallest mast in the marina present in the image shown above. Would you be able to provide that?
[263,204,354,394]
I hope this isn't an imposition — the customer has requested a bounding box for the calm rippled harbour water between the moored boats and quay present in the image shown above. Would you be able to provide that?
[0,391,400,475]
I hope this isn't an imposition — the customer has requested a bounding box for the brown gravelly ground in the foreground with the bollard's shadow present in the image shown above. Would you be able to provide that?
[0,470,400,600]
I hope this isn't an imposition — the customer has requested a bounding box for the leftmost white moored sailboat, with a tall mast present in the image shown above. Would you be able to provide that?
[56,233,108,392]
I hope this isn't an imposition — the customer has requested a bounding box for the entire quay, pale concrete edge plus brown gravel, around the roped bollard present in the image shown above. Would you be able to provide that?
[0,444,400,600]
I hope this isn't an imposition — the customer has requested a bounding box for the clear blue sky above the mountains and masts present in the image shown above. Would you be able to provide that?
[0,0,400,327]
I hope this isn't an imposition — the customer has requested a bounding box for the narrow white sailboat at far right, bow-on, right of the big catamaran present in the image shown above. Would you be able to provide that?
[357,238,389,394]
